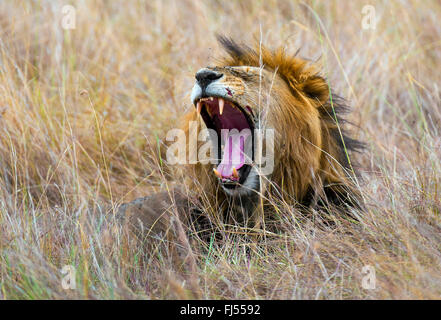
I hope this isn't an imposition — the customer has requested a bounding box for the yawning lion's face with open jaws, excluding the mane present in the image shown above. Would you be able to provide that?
[191,66,282,196]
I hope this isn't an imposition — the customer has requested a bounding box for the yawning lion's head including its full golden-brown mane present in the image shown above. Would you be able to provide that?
[187,38,361,218]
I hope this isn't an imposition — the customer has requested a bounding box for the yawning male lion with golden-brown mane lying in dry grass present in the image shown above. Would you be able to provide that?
[118,37,362,240]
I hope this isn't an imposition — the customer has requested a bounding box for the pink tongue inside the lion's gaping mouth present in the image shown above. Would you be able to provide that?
[217,132,250,178]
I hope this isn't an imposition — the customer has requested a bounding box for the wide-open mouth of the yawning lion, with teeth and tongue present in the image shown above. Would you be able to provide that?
[196,97,254,188]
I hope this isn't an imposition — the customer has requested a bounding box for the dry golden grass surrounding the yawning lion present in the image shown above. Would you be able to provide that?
[0,0,441,299]
